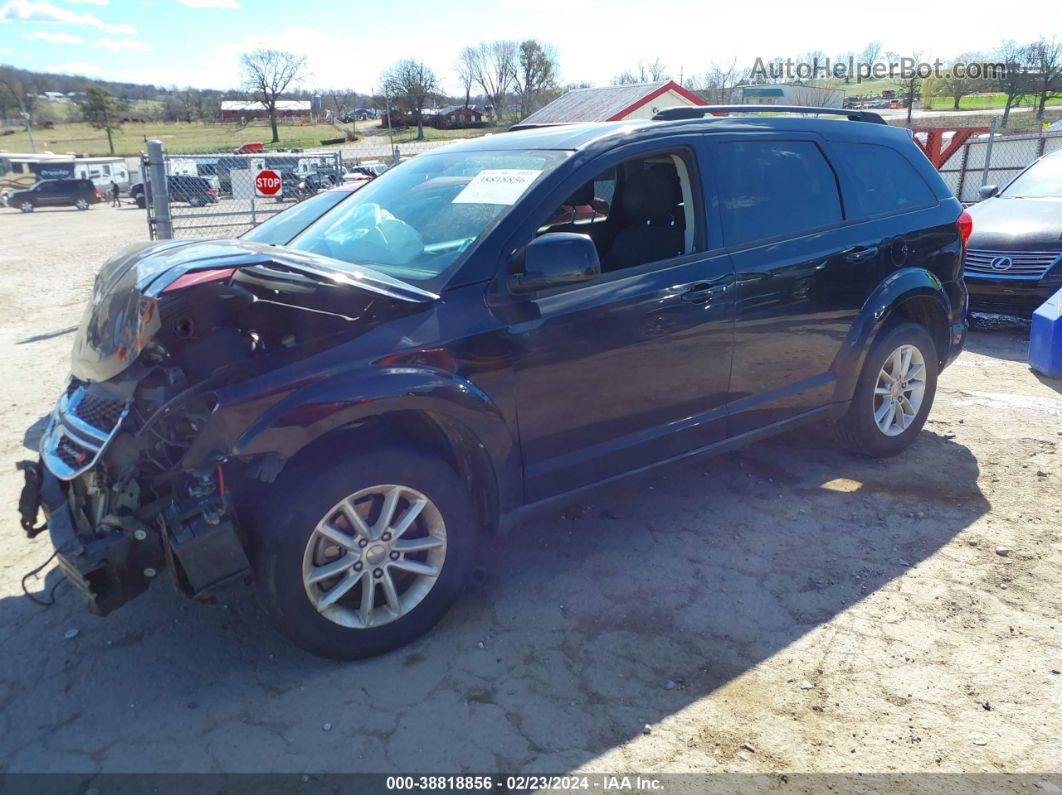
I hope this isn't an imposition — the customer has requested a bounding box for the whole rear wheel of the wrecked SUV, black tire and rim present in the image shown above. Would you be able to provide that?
[835,323,938,457]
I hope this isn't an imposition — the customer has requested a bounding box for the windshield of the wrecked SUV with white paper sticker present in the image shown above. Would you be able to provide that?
[290,151,569,287]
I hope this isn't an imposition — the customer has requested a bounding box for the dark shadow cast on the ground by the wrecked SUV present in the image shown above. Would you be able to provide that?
[0,431,989,773]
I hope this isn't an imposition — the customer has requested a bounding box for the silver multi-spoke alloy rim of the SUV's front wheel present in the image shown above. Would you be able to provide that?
[303,484,446,629]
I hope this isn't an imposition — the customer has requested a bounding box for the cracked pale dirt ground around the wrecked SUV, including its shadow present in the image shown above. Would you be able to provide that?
[0,202,1062,773]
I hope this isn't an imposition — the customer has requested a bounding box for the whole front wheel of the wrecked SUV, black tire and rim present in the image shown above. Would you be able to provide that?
[254,448,477,659]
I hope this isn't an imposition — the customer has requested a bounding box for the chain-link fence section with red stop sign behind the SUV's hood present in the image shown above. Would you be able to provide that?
[142,138,447,240]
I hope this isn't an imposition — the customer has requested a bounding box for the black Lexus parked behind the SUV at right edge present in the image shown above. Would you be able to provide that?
[963,151,1062,317]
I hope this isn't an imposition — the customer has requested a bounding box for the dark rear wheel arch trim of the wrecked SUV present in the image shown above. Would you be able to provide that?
[832,267,954,401]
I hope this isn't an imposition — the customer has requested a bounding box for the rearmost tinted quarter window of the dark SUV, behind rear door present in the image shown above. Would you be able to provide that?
[830,143,937,218]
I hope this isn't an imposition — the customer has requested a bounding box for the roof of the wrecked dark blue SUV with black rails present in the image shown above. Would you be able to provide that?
[435,116,911,152]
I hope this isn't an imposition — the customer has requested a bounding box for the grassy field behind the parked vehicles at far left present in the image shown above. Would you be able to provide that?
[0,122,342,156]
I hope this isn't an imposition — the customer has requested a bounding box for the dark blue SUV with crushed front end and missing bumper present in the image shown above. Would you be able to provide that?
[20,107,970,658]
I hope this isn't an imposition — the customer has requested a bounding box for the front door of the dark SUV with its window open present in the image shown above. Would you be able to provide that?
[501,148,734,502]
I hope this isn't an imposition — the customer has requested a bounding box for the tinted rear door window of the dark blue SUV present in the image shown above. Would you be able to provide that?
[718,141,841,246]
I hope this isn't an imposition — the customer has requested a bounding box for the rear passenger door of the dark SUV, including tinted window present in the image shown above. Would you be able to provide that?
[713,134,884,435]
